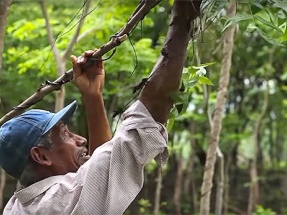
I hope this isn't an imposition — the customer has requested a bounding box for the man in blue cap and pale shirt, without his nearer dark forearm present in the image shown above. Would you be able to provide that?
[0,51,170,215]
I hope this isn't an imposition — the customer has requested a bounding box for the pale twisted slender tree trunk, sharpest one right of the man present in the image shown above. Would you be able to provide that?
[200,1,236,215]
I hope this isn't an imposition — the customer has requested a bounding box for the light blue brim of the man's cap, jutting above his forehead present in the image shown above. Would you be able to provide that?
[43,100,77,135]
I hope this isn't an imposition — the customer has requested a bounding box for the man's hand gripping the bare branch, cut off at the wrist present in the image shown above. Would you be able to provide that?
[71,49,105,96]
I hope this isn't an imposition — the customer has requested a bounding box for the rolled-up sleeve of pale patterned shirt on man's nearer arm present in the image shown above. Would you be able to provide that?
[79,101,168,215]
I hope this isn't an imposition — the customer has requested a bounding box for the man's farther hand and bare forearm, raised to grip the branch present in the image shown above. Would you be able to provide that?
[71,50,112,155]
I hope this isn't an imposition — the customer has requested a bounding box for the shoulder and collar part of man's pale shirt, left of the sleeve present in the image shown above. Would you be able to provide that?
[3,173,82,215]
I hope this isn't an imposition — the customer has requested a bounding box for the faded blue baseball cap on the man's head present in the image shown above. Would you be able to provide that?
[0,101,77,179]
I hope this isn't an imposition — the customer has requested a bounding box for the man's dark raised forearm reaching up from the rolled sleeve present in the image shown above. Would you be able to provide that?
[139,0,201,124]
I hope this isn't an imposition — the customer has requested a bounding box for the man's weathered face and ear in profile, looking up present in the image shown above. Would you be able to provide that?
[47,122,90,174]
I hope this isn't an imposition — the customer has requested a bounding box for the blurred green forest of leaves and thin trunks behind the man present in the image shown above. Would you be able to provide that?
[0,0,287,215]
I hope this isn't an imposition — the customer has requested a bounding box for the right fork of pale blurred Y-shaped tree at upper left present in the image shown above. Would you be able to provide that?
[63,0,91,59]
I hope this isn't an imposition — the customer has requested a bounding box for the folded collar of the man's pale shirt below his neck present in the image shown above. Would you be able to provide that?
[14,175,64,204]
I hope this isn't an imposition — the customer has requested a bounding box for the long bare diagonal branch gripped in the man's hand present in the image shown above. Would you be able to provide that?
[0,0,162,126]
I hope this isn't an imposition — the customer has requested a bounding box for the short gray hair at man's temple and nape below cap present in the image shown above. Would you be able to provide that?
[19,131,52,187]
